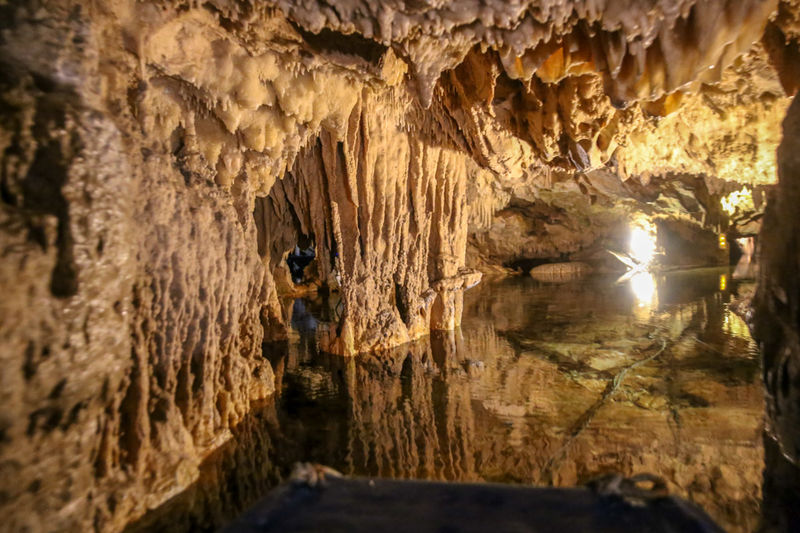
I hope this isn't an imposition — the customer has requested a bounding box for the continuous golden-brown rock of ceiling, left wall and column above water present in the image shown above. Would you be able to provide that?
[0,0,798,531]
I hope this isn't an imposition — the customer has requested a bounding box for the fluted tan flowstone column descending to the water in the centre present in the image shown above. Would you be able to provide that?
[259,90,480,354]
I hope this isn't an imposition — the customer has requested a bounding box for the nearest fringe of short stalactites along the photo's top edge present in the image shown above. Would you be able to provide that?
[277,0,777,105]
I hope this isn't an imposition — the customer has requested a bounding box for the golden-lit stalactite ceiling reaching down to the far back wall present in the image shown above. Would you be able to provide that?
[111,0,797,270]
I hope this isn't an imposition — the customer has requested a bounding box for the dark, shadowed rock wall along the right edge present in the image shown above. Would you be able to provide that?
[751,94,800,531]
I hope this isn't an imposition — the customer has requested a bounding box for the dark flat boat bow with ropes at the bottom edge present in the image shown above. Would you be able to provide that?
[224,478,722,533]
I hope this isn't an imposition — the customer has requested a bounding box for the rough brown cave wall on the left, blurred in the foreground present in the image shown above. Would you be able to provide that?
[0,3,274,531]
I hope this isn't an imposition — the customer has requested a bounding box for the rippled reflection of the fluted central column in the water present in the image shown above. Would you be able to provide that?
[347,333,475,480]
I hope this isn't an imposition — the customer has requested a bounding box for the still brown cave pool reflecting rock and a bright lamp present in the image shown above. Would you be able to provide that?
[125,270,763,531]
